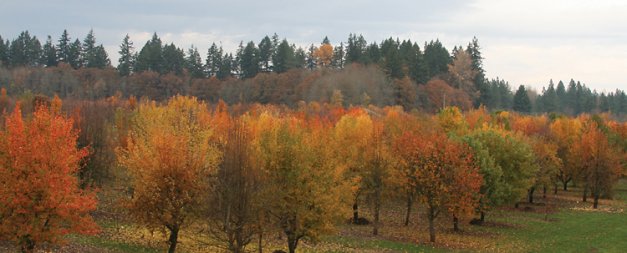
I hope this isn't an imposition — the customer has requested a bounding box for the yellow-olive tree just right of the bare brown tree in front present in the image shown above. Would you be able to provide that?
[257,114,354,253]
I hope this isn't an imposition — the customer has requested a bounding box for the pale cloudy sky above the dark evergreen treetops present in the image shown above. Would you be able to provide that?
[0,0,627,92]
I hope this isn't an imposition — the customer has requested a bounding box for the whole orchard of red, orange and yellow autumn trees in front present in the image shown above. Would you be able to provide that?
[0,93,627,252]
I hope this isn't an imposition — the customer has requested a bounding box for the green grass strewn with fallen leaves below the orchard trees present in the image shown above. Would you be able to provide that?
[69,179,627,252]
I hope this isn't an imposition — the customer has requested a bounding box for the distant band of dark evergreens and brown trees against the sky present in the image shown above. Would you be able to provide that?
[0,30,627,115]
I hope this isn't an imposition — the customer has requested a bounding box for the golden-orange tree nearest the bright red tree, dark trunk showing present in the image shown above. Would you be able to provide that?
[117,96,220,252]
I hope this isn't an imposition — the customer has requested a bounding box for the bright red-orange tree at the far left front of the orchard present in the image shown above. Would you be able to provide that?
[0,101,98,252]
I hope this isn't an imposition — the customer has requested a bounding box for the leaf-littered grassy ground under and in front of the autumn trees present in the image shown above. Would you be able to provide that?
[0,179,627,252]
